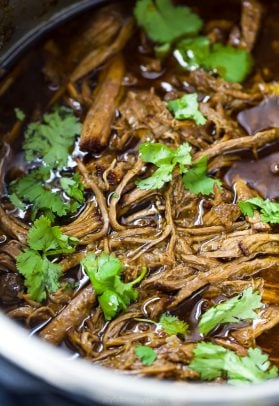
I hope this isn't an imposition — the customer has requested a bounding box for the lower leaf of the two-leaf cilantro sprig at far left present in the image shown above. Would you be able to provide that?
[16,248,62,302]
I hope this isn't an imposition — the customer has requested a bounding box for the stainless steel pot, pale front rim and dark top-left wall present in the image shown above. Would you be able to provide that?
[0,0,279,406]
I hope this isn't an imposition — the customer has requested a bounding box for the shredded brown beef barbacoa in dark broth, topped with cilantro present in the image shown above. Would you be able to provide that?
[0,0,279,384]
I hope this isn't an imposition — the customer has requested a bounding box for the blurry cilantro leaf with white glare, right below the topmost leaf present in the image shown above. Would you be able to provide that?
[174,37,252,82]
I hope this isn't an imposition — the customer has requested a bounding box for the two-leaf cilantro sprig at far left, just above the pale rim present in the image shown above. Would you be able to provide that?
[16,216,78,302]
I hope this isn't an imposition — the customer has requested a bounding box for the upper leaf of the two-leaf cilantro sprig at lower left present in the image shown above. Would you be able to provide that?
[27,216,78,255]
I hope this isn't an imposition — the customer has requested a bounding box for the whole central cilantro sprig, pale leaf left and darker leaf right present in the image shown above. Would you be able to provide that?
[136,142,222,195]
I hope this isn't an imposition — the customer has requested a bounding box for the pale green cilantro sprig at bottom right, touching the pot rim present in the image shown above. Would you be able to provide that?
[189,342,278,385]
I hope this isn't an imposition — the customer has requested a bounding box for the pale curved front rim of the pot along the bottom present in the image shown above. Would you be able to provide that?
[0,313,279,405]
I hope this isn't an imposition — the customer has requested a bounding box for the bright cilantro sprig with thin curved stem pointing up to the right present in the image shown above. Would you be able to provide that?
[81,252,147,320]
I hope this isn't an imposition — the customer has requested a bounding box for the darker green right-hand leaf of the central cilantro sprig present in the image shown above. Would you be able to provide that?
[183,155,222,195]
